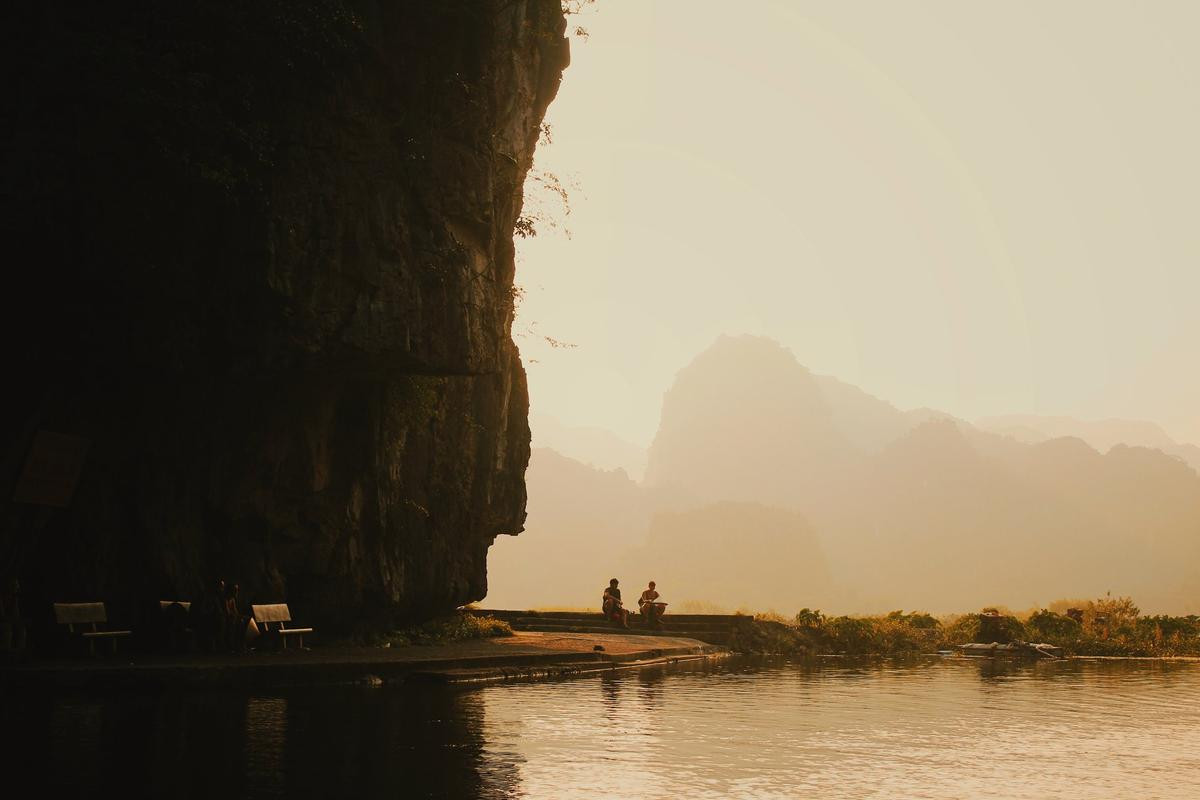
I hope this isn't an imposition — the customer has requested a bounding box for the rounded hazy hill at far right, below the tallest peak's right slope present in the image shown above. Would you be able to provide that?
[840,421,1200,610]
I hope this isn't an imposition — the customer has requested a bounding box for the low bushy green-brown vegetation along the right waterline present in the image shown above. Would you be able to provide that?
[733,596,1200,657]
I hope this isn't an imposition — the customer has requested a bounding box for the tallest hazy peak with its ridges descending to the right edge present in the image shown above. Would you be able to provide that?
[647,337,1200,610]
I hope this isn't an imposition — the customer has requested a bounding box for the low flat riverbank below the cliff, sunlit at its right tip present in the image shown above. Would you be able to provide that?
[0,632,728,690]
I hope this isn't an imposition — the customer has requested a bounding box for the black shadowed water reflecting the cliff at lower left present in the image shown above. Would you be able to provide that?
[0,687,521,798]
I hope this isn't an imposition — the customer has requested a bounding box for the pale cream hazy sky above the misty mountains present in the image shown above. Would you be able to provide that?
[515,0,1200,444]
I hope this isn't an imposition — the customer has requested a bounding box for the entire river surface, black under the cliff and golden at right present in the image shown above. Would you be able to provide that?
[9,660,1200,800]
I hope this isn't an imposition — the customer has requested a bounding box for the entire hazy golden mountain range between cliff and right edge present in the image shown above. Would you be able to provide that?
[488,337,1200,613]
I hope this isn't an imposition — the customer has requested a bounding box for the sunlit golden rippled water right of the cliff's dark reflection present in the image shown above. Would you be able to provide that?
[482,661,1200,799]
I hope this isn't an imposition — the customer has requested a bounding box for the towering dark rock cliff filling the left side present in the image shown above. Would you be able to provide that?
[0,0,569,628]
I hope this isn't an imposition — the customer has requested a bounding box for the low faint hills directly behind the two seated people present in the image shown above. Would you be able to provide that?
[486,449,829,609]
